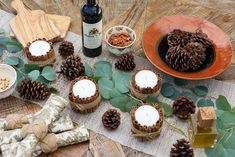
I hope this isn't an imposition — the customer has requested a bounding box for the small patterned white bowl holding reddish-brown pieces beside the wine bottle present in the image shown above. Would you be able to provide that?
[105,25,136,56]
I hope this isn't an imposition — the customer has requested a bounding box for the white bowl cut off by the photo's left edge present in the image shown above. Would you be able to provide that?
[0,64,17,99]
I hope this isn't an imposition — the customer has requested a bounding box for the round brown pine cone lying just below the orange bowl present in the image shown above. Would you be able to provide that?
[173,96,196,119]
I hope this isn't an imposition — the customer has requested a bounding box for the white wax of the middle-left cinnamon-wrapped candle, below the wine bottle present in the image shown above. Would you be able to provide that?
[73,80,96,98]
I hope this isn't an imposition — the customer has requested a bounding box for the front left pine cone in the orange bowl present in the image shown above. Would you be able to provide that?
[165,46,191,71]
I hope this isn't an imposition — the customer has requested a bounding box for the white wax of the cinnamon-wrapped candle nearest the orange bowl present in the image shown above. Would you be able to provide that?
[135,70,158,88]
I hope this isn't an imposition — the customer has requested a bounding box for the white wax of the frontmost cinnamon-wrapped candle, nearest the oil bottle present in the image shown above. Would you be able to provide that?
[135,105,159,127]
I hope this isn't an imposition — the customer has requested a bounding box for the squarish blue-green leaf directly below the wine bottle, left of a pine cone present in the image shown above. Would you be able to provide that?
[94,61,112,79]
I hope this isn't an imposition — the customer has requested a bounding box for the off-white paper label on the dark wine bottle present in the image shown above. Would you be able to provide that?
[83,20,102,49]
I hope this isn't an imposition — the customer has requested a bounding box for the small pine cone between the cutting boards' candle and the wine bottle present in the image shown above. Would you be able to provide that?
[59,41,74,58]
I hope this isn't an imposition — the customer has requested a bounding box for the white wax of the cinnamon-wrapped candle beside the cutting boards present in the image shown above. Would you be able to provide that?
[29,40,51,56]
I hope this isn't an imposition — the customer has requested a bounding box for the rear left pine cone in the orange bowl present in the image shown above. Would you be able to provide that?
[167,29,192,47]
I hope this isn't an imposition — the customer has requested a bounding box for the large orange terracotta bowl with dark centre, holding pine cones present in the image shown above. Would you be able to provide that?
[142,15,233,80]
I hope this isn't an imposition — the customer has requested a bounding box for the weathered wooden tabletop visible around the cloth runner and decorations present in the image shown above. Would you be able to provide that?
[0,0,235,157]
